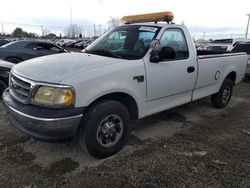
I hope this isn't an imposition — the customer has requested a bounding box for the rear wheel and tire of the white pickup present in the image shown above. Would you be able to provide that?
[211,78,233,109]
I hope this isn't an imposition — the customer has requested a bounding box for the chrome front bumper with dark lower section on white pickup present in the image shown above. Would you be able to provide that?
[3,89,82,142]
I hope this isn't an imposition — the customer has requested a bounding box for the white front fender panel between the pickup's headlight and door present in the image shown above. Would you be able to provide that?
[61,60,146,116]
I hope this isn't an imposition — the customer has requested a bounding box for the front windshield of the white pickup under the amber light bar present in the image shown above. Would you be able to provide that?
[85,25,159,59]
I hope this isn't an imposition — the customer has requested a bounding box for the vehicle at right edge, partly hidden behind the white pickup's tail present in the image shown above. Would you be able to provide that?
[232,42,250,78]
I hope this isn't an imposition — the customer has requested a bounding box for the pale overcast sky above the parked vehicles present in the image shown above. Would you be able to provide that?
[0,0,250,38]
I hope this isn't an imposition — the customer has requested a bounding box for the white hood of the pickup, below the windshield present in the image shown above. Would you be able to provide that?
[12,53,121,83]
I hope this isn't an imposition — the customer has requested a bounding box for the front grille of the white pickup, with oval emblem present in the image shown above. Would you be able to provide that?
[9,74,32,104]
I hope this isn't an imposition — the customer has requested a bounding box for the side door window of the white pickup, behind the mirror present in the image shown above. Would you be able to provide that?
[160,29,189,60]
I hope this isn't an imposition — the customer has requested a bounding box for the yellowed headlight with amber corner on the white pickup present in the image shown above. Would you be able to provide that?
[32,86,75,106]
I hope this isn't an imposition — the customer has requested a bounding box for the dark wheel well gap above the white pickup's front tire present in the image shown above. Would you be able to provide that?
[89,92,138,120]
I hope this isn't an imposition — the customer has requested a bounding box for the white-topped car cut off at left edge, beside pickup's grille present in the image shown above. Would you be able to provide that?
[0,60,15,99]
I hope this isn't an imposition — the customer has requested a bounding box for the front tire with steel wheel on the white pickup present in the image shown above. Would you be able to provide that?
[78,100,131,159]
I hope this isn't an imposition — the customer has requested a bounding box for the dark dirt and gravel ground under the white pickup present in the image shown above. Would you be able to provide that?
[0,81,250,188]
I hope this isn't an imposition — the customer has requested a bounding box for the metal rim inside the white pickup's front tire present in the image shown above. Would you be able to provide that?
[96,114,123,147]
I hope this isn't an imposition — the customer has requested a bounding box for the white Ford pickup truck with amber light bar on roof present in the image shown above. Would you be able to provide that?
[3,12,247,158]
